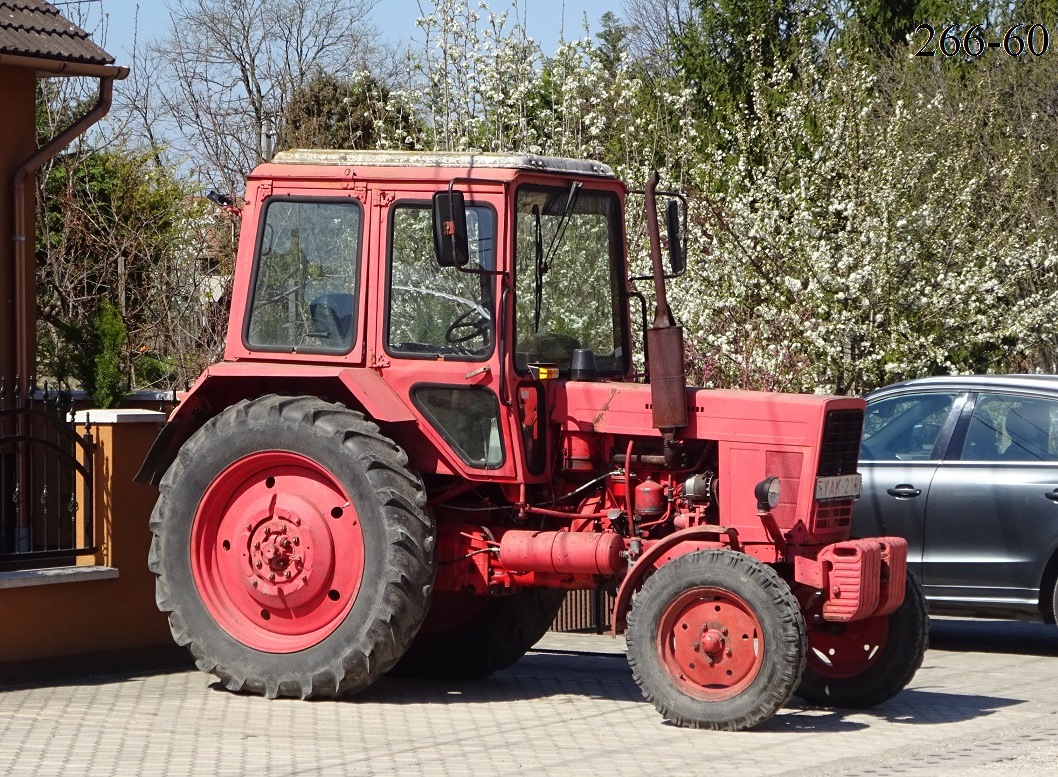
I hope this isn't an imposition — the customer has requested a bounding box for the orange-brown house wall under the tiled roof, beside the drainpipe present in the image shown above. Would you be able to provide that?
[0,66,37,386]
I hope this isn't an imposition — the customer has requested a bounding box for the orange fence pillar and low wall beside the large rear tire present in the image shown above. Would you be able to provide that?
[0,414,172,662]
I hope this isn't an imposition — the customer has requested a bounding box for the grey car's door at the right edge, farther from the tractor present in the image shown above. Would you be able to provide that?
[922,392,1058,610]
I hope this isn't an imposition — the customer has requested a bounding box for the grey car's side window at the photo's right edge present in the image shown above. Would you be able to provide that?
[962,394,1058,462]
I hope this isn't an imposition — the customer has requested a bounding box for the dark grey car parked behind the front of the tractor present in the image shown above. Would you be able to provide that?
[853,375,1058,622]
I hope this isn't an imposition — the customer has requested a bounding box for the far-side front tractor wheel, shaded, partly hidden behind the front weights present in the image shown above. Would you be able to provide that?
[797,572,929,709]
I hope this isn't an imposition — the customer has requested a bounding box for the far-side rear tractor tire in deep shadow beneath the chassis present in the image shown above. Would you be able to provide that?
[393,589,566,680]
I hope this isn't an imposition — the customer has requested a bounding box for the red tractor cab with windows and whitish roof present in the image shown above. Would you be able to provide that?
[215,151,634,484]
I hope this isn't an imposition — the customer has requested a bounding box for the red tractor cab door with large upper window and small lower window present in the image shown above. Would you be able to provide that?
[369,185,519,481]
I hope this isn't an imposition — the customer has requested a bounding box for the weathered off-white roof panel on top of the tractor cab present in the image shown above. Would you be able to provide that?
[272,148,617,178]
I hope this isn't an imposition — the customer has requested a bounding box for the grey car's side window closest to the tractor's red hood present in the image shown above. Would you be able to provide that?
[860,393,956,462]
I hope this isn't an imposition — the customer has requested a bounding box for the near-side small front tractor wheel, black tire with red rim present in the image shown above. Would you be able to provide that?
[626,550,805,730]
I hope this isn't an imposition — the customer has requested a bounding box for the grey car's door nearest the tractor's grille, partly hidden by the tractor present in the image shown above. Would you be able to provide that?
[853,391,960,573]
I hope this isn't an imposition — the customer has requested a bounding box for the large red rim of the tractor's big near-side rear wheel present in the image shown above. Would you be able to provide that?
[190,451,364,653]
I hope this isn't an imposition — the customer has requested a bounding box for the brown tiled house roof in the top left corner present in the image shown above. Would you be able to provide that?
[0,0,114,65]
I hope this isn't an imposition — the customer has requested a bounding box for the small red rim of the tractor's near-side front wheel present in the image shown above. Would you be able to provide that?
[657,588,765,702]
